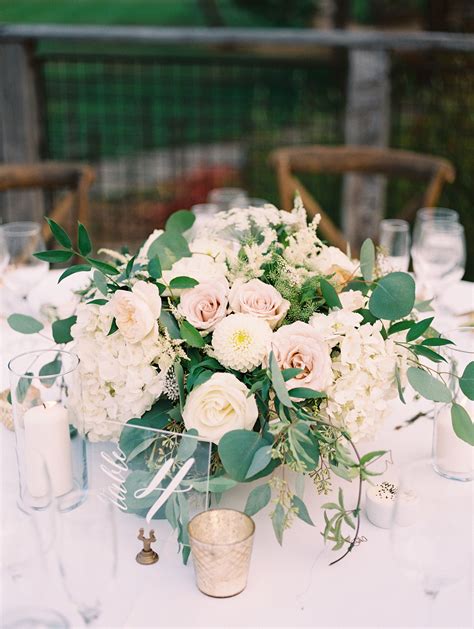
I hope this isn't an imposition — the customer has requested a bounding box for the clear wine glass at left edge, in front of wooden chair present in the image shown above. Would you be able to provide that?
[0,221,49,305]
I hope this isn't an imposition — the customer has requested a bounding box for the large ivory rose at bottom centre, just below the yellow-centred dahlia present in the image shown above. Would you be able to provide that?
[183,373,258,443]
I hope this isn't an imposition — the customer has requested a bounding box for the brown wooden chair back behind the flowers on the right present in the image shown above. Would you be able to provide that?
[270,145,456,250]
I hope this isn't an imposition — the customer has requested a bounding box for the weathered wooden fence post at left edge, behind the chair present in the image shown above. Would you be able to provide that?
[0,41,43,222]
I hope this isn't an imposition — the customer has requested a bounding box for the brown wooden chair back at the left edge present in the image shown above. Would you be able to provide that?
[0,162,95,241]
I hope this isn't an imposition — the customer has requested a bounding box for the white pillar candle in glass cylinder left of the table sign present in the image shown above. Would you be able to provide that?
[23,403,73,497]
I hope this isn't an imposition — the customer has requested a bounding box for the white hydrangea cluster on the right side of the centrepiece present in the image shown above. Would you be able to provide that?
[322,322,398,441]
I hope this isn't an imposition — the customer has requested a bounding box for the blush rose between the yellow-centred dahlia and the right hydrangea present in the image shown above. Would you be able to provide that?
[270,321,333,391]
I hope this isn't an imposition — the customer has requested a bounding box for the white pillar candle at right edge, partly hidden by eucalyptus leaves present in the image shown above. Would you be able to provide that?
[433,404,474,474]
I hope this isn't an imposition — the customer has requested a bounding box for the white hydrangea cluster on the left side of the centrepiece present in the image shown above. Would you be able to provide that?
[71,304,180,441]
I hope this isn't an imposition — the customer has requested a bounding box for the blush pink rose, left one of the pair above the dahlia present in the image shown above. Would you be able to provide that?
[178,279,229,332]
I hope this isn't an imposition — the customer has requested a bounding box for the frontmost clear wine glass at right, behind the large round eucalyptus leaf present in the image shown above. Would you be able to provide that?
[413,220,466,310]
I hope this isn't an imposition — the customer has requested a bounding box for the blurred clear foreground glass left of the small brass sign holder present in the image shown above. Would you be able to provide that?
[56,491,117,625]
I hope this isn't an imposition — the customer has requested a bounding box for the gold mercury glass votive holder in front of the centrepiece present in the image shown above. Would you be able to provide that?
[188,509,255,598]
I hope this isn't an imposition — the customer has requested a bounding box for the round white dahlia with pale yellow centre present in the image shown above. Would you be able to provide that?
[212,314,272,372]
